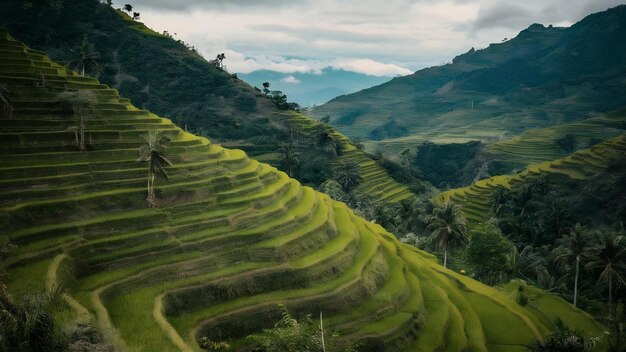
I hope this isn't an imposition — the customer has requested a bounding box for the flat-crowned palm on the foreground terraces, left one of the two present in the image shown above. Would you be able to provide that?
[55,89,98,151]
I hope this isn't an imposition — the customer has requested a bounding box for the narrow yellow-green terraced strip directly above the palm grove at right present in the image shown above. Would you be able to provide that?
[435,133,626,224]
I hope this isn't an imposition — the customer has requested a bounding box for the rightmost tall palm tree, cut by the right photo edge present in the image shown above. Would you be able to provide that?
[586,232,626,320]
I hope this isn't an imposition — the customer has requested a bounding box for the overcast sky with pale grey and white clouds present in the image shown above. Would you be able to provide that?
[115,0,626,77]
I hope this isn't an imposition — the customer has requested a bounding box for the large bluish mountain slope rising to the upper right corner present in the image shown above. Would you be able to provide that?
[314,6,626,145]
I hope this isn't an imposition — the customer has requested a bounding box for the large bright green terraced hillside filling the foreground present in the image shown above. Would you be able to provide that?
[0,34,603,351]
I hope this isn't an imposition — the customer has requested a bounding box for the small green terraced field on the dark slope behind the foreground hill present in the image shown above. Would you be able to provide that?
[289,114,415,203]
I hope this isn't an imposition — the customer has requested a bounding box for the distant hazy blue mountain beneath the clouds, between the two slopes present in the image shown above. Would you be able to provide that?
[237,68,390,106]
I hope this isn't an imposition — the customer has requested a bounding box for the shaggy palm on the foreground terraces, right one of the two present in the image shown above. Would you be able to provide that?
[138,131,173,207]
